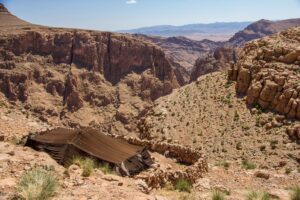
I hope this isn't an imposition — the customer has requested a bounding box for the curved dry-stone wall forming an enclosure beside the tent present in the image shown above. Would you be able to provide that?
[113,135,208,188]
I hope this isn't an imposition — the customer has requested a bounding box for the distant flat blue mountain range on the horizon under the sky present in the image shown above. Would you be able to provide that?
[118,22,252,41]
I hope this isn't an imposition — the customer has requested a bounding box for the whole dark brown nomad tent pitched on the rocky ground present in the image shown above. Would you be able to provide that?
[26,128,152,176]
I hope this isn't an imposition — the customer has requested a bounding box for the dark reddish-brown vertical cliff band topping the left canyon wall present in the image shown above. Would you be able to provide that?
[0,29,176,84]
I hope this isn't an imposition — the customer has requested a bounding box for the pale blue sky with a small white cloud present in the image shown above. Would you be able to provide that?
[0,0,300,31]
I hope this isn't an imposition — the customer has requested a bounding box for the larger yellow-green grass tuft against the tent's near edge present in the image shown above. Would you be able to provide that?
[72,156,96,177]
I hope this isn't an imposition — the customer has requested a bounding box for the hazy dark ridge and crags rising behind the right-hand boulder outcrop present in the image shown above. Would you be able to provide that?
[190,19,300,82]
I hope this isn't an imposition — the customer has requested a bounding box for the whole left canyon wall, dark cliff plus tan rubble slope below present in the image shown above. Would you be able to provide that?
[0,4,179,138]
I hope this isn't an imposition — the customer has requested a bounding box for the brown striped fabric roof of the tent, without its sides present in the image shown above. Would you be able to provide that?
[32,128,144,165]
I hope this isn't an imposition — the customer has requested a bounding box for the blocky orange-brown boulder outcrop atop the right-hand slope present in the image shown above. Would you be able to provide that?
[229,28,300,119]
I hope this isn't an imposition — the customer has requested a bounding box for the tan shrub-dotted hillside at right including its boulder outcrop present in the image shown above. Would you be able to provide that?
[140,28,300,178]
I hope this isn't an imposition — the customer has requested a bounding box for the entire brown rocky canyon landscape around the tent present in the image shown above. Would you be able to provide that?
[0,4,300,200]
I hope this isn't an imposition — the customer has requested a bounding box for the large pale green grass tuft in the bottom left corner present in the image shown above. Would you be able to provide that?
[17,168,58,200]
